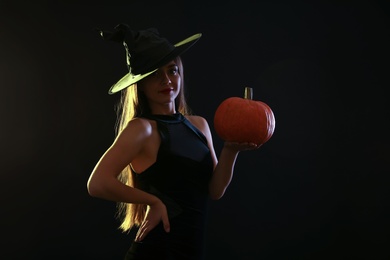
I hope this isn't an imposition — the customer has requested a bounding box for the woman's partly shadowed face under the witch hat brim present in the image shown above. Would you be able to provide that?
[139,61,181,111]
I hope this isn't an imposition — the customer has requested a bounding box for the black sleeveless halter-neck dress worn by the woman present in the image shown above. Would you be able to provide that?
[125,113,213,260]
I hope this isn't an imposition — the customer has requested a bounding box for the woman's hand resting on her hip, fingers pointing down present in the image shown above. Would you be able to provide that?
[135,200,170,242]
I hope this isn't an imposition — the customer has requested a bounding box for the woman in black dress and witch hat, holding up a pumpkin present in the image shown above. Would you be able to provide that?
[87,24,258,260]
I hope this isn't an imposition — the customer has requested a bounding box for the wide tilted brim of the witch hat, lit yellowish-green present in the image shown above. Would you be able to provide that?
[108,33,202,94]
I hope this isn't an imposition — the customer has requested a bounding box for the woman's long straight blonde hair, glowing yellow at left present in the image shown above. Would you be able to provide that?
[116,57,191,232]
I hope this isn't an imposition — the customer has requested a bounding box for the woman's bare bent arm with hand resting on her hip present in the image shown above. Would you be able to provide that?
[87,119,170,238]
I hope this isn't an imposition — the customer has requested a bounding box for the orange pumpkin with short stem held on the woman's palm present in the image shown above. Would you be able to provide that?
[214,87,275,145]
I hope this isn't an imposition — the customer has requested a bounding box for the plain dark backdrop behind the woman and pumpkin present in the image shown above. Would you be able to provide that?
[0,0,390,260]
